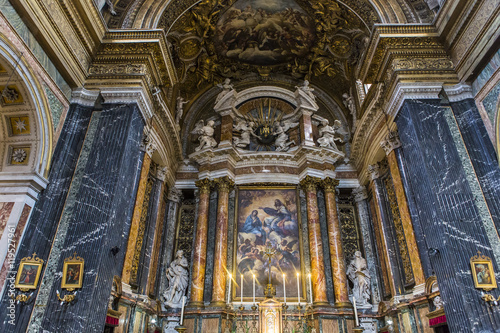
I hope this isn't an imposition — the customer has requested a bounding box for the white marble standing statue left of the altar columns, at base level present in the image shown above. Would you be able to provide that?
[163,250,189,308]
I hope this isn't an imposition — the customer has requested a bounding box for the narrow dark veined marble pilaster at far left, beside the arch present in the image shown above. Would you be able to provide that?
[0,104,93,332]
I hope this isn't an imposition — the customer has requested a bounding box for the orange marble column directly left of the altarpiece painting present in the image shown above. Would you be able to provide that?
[210,176,234,307]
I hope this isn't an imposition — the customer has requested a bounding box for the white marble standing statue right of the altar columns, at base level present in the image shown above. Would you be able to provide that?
[347,251,372,309]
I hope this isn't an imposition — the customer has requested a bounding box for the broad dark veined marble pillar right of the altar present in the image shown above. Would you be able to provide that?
[396,99,500,332]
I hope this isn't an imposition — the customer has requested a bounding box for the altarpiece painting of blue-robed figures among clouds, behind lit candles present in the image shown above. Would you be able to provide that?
[233,187,304,301]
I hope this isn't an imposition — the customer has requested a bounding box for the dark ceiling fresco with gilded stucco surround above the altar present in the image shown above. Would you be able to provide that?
[167,0,369,98]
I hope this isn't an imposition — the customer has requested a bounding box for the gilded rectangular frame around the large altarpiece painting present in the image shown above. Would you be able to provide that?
[231,183,307,303]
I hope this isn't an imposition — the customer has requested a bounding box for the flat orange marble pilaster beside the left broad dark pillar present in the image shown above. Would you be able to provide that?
[122,139,153,284]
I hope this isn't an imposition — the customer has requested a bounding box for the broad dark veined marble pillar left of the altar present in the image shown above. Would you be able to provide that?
[32,104,144,333]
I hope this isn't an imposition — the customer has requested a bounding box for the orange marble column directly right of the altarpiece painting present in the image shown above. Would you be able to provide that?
[300,176,329,306]
